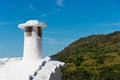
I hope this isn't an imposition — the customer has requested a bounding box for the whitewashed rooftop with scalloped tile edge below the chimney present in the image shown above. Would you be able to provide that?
[0,57,64,80]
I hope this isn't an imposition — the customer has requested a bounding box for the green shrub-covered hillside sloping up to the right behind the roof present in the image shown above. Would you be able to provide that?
[52,31,120,80]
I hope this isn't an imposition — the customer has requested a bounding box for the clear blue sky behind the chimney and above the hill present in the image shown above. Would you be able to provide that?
[0,0,120,57]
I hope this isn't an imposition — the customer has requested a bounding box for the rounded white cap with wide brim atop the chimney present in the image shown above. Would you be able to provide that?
[18,20,47,29]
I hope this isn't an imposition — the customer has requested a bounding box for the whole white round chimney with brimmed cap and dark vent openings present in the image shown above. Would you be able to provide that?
[18,20,47,61]
